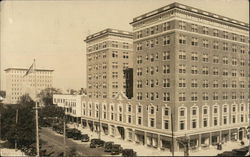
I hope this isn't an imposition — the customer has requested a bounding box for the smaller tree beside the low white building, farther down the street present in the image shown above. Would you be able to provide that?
[38,88,62,106]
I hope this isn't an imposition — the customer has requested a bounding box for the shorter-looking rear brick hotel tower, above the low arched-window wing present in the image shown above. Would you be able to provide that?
[85,29,133,98]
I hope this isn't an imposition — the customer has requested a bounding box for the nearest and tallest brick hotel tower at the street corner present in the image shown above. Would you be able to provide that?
[131,3,249,150]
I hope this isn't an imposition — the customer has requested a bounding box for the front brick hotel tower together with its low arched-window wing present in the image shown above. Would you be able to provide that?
[53,3,250,151]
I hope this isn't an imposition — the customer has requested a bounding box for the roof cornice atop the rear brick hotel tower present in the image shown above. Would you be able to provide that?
[84,28,133,42]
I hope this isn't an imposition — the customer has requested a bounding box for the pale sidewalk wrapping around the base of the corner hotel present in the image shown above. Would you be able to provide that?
[68,124,249,156]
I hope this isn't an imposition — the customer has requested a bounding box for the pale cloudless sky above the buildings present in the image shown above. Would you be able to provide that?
[0,0,249,90]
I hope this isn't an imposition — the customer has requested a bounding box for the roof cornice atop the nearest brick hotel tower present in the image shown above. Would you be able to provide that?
[130,2,249,28]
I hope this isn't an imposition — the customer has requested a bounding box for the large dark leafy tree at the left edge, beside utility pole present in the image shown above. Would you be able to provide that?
[1,95,36,148]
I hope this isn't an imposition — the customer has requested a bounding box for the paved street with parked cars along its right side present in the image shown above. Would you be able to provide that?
[40,128,108,156]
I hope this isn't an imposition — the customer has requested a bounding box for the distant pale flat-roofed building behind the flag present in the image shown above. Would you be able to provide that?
[5,68,54,104]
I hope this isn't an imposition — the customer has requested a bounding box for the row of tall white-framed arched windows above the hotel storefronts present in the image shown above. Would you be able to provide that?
[82,100,249,130]
